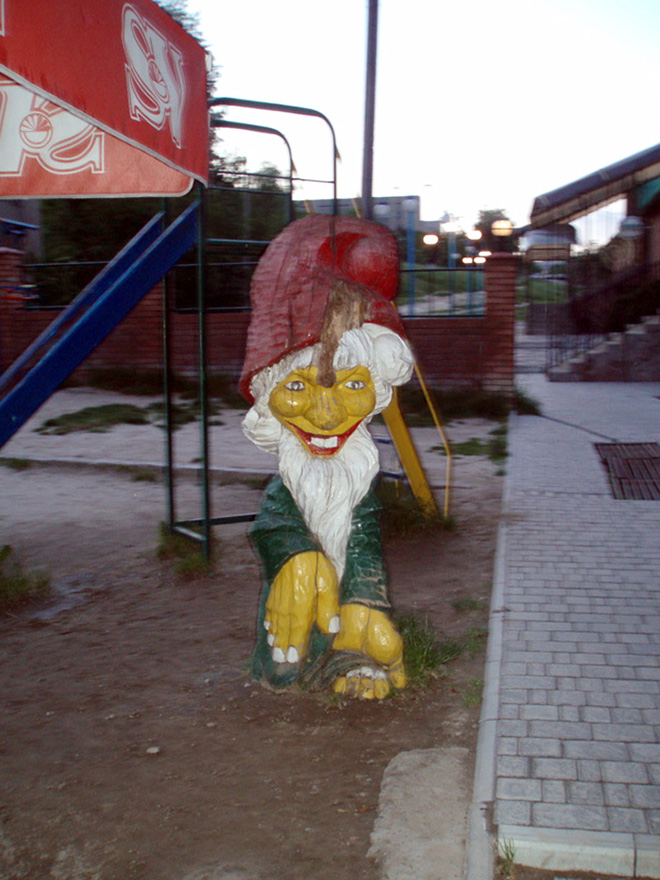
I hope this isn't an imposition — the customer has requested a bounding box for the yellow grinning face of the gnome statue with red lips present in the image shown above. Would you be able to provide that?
[268,366,376,455]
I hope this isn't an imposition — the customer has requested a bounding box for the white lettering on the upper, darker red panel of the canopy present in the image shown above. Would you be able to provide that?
[122,3,186,147]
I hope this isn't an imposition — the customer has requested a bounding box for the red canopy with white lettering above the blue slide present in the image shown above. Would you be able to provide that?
[0,0,209,197]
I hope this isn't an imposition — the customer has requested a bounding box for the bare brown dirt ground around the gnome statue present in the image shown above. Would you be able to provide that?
[0,404,502,880]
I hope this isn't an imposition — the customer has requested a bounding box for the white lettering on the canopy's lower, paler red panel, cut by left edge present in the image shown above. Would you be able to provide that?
[0,79,104,177]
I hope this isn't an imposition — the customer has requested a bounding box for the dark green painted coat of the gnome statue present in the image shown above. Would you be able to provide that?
[250,476,390,688]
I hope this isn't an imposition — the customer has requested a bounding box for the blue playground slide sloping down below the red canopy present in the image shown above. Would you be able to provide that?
[0,204,198,447]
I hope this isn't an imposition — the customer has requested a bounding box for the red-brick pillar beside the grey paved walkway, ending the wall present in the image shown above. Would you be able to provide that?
[484,253,518,398]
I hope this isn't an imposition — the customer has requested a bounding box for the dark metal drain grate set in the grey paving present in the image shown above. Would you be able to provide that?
[594,443,660,501]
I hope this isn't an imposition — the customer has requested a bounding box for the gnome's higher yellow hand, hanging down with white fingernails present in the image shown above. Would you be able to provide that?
[264,550,339,663]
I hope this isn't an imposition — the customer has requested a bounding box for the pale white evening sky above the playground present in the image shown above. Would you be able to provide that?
[183,0,660,230]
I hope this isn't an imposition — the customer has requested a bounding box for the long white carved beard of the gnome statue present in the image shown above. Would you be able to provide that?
[278,423,378,580]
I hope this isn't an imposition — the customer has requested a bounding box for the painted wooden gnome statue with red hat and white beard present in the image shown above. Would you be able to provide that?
[240,215,413,699]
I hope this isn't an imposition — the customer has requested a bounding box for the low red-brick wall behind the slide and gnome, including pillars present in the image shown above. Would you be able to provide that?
[0,252,517,395]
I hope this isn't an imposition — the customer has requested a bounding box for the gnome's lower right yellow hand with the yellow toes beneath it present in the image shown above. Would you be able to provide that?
[332,604,406,700]
